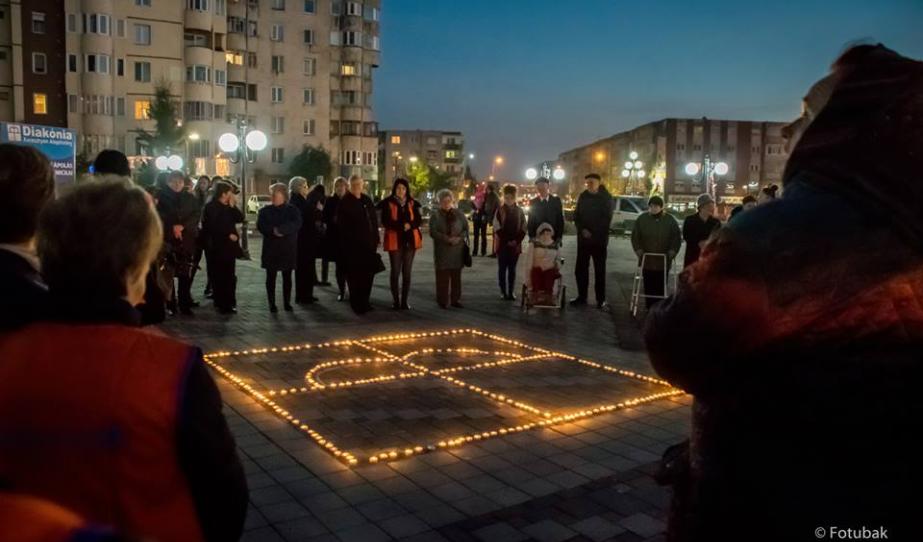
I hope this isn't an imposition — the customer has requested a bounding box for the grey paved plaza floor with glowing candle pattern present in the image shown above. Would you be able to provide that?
[163,237,691,541]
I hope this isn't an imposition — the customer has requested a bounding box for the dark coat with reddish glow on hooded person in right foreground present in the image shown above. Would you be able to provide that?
[645,173,923,541]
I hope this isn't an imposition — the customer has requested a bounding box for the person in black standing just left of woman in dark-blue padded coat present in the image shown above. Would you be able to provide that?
[199,181,244,314]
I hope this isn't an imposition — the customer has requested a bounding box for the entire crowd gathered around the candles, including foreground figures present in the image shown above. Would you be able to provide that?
[0,45,923,541]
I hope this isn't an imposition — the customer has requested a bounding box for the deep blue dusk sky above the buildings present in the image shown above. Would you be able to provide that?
[375,0,923,178]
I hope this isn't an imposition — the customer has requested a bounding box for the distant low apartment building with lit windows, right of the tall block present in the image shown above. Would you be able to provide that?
[378,130,466,189]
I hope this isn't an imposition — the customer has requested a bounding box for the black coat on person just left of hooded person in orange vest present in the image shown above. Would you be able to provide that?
[336,192,379,274]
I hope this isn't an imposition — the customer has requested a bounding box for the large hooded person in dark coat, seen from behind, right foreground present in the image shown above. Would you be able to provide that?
[645,45,923,542]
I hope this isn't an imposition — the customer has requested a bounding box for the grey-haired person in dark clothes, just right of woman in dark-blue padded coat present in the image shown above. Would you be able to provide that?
[288,177,320,305]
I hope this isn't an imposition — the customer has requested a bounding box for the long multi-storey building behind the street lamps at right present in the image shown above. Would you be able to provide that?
[560,118,788,211]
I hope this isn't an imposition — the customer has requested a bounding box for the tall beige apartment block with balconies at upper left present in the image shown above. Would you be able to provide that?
[0,0,380,196]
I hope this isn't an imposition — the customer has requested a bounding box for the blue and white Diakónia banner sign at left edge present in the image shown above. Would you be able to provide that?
[0,122,77,186]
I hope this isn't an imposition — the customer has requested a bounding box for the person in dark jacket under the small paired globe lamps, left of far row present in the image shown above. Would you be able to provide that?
[157,171,201,316]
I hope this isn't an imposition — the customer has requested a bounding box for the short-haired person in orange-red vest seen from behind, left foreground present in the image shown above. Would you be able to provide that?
[0,179,248,541]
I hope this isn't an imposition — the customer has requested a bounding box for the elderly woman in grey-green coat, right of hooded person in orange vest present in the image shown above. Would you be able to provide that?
[429,189,468,309]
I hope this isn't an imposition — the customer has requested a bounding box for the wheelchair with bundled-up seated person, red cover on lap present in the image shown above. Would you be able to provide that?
[519,223,567,311]
